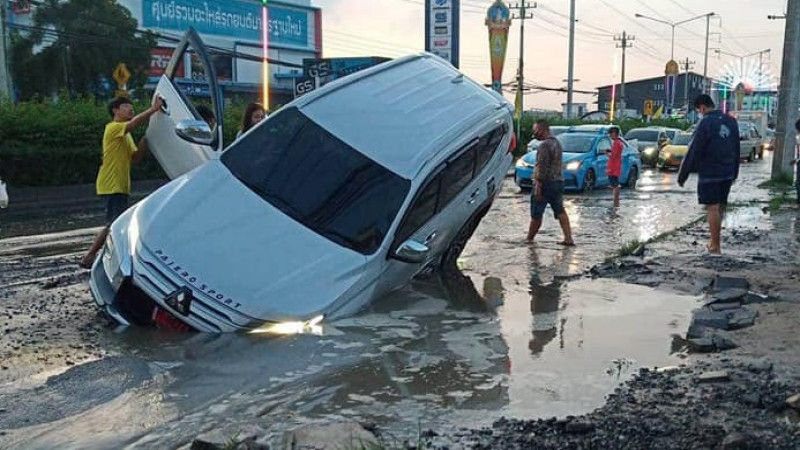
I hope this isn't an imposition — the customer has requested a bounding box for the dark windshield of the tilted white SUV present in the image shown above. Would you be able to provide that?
[221,108,411,254]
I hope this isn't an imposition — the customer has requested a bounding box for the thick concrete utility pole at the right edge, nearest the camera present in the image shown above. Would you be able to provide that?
[772,0,800,179]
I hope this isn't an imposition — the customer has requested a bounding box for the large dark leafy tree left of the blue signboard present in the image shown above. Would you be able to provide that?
[12,0,157,99]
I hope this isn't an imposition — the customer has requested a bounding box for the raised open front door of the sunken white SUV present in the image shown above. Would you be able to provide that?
[145,28,223,179]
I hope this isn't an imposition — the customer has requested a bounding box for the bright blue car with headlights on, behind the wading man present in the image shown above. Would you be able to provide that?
[514,126,642,191]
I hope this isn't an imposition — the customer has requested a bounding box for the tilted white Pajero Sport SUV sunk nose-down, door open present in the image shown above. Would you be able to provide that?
[89,30,513,332]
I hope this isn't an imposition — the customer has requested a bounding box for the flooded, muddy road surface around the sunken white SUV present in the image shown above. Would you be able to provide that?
[0,154,770,449]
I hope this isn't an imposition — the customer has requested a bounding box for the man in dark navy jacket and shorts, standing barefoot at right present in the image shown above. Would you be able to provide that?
[678,94,740,255]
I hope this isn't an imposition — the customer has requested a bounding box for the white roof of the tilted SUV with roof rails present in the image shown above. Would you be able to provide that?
[293,53,513,179]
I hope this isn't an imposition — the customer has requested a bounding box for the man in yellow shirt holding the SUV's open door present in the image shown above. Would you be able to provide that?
[80,96,164,269]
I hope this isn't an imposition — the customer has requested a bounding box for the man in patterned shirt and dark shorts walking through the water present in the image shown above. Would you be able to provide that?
[527,119,575,246]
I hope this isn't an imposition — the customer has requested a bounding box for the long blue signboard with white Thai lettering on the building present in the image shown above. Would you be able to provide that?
[142,0,314,49]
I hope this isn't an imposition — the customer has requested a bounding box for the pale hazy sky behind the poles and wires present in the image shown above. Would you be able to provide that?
[311,0,786,110]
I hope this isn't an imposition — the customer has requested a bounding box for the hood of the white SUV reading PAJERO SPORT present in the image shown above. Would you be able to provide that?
[137,160,367,321]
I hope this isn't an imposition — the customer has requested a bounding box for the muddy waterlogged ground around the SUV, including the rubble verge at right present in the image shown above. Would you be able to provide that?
[0,156,800,449]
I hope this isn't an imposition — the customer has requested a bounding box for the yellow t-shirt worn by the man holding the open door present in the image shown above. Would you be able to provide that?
[97,122,136,195]
